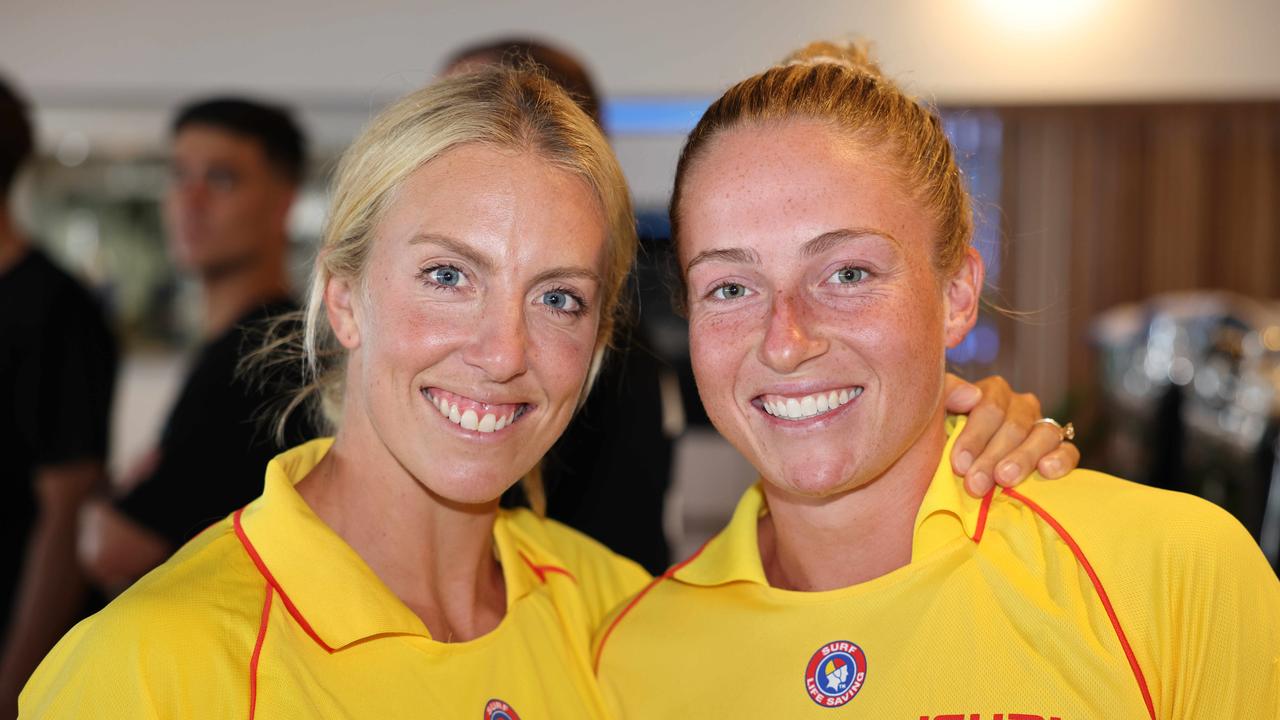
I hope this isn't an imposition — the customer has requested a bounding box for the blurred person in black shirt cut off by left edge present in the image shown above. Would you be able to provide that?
[0,75,116,717]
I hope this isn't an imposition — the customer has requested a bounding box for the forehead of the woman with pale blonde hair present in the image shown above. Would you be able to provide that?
[381,143,607,265]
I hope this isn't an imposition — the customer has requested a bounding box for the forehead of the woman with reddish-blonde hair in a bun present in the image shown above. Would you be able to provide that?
[680,120,932,259]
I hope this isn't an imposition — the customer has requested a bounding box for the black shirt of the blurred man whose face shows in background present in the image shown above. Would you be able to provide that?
[115,300,315,547]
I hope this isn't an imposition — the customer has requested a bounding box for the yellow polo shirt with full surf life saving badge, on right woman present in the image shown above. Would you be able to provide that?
[595,420,1280,720]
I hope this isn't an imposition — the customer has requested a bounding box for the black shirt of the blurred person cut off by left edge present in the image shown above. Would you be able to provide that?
[0,250,116,625]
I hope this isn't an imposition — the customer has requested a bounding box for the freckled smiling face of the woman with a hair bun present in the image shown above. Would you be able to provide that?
[680,120,982,497]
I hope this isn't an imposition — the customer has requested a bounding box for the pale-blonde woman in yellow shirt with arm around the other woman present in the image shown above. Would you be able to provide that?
[22,69,1056,720]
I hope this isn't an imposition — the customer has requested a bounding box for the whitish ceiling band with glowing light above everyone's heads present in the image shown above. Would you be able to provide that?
[0,0,1280,198]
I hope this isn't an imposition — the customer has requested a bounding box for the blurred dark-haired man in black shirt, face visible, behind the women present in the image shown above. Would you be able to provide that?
[79,97,314,593]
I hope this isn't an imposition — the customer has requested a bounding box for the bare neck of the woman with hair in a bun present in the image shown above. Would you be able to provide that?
[759,407,947,592]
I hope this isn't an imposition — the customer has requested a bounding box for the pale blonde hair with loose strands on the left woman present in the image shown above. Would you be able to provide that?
[260,67,636,510]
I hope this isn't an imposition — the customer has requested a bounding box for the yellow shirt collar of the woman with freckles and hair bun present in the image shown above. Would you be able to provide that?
[671,416,991,585]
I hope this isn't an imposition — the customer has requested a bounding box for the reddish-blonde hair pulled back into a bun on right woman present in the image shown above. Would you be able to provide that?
[671,42,973,294]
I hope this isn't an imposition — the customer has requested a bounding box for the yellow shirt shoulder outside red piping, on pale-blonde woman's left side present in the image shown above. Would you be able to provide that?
[22,520,266,717]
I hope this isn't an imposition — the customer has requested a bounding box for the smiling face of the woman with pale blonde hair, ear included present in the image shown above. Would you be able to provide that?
[326,145,605,503]
